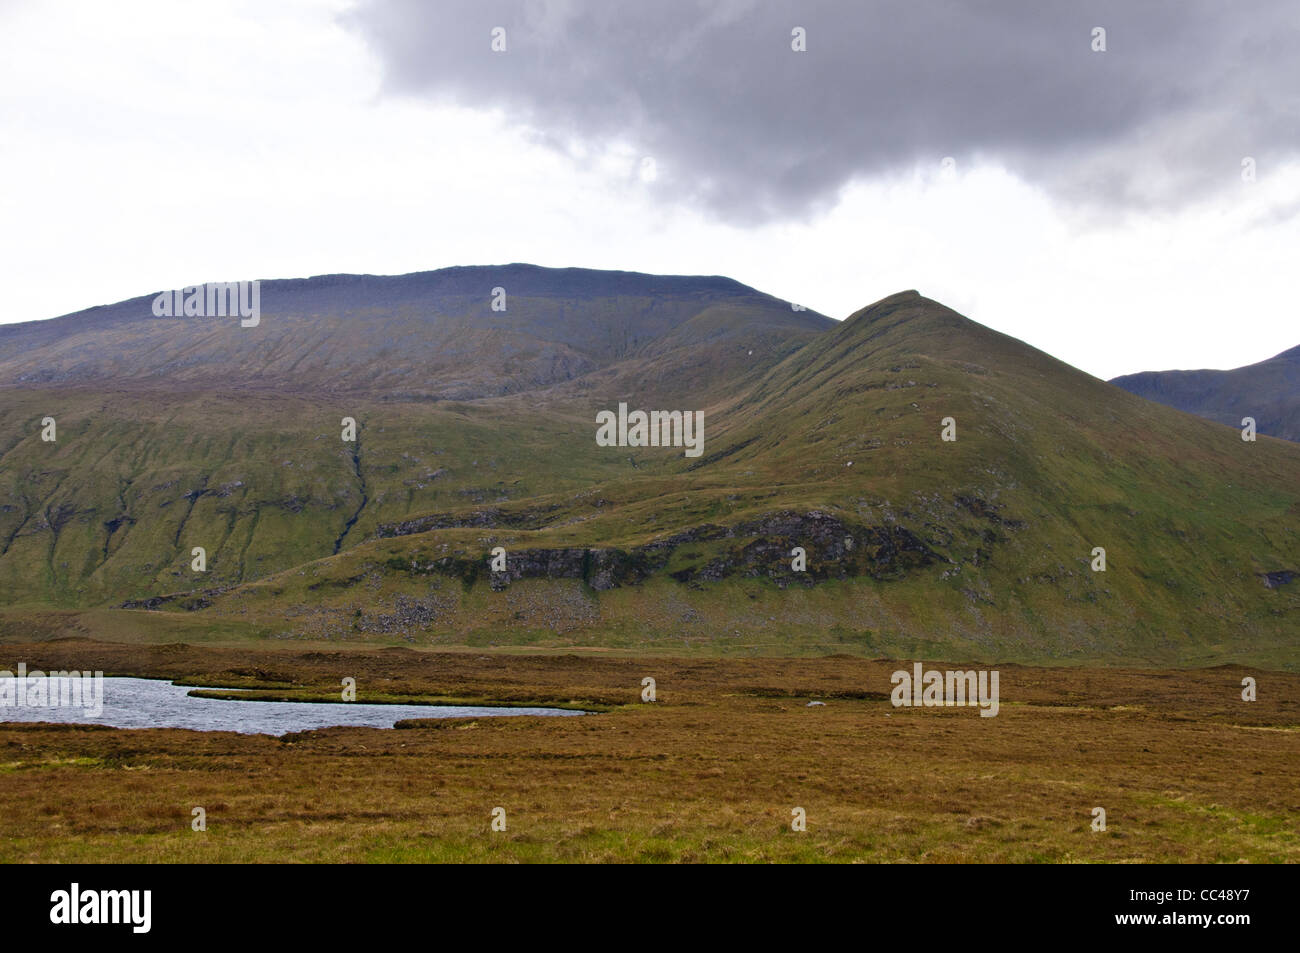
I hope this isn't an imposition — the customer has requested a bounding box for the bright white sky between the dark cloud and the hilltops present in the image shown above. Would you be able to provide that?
[0,3,1300,377]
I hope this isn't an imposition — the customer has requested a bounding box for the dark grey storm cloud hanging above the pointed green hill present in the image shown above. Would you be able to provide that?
[343,0,1300,222]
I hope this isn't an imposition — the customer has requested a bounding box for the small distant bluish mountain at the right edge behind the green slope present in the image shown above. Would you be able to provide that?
[1112,347,1300,442]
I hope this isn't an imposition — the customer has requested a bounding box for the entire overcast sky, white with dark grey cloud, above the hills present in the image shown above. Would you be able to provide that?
[0,0,1300,377]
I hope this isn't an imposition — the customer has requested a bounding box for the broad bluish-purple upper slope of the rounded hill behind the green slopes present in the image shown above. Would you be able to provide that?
[0,264,835,399]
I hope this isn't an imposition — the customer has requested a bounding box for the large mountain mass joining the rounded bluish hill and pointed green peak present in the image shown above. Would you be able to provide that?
[0,265,1300,667]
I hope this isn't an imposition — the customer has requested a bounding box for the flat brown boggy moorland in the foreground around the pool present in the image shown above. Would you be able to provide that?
[0,640,1300,862]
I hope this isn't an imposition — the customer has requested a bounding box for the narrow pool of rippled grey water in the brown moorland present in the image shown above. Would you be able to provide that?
[0,679,584,735]
